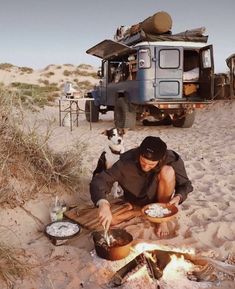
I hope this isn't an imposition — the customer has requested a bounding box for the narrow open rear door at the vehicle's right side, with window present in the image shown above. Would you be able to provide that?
[199,45,214,99]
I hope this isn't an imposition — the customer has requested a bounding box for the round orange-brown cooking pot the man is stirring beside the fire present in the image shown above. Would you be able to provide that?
[92,229,133,261]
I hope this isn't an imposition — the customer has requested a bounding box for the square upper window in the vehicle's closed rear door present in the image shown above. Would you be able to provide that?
[159,49,180,69]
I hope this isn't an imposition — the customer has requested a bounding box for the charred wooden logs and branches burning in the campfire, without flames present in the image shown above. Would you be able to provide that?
[108,246,235,289]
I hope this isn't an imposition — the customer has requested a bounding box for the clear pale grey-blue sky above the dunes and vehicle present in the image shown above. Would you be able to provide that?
[0,0,235,73]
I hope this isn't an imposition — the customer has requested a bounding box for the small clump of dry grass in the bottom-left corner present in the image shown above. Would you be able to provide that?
[0,243,31,288]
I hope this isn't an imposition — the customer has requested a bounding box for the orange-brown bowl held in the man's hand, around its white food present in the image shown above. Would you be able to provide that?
[142,203,178,223]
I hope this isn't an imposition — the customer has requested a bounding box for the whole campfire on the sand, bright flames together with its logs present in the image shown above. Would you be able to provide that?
[96,243,235,289]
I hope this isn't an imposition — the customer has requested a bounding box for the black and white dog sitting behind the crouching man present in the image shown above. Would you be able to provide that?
[93,128,125,198]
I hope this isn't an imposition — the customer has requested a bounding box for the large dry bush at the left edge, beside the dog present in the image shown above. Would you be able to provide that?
[0,86,84,207]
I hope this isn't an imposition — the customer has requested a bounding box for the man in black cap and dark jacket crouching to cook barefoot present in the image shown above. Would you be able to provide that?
[90,136,193,238]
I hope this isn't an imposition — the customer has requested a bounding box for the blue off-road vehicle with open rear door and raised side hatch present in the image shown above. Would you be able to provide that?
[85,11,214,128]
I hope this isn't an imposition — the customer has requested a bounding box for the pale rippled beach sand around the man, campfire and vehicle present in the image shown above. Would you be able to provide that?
[0,91,235,289]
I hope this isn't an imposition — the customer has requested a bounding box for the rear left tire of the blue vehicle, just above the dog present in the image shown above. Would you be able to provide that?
[114,97,136,129]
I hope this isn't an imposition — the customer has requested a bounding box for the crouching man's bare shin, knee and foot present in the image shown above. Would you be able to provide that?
[155,166,175,238]
